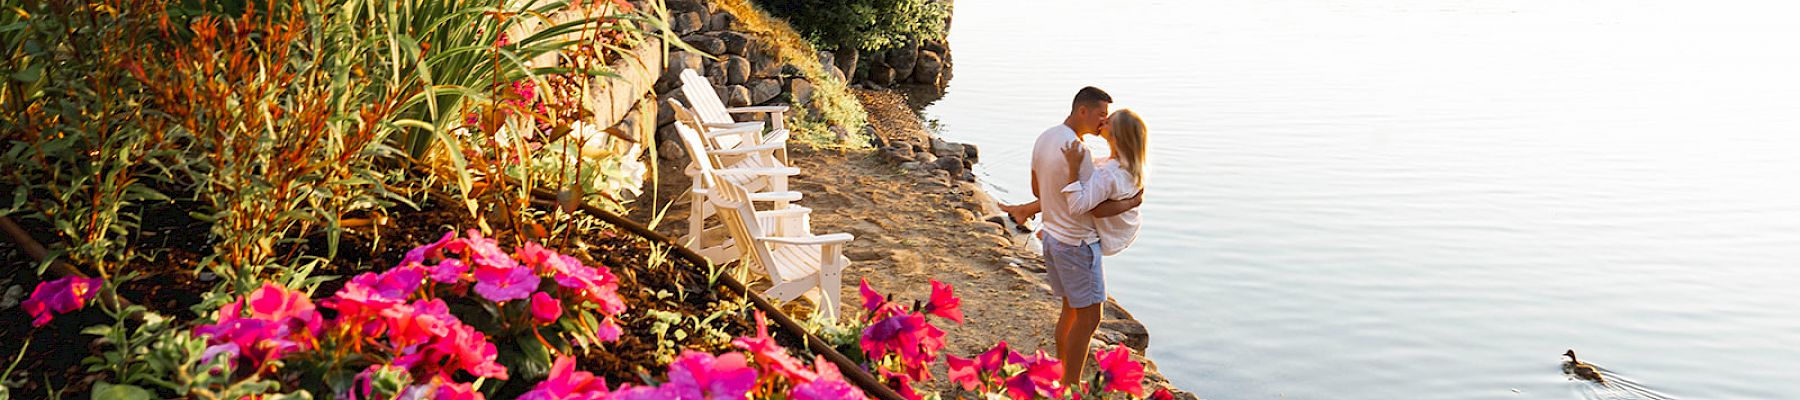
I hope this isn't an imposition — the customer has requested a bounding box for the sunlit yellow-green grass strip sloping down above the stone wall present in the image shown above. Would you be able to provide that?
[715,0,869,148]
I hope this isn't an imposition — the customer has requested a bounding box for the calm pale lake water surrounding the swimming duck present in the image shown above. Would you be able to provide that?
[923,0,1800,400]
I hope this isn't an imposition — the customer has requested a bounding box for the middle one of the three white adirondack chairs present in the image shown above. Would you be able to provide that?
[675,106,808,263]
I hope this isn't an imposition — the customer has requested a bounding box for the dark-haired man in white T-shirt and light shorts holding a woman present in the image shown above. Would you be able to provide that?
[1013,86,1143,387]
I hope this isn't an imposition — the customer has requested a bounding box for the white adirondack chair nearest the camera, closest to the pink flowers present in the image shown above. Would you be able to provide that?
[709,182,855,319]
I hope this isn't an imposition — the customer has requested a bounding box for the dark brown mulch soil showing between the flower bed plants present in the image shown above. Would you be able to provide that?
[0,190,810,398]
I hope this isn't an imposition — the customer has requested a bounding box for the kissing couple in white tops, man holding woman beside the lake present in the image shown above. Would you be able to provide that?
[1001,86,1148,387]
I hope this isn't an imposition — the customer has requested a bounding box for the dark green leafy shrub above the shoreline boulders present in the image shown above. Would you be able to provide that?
[760,0,950,50]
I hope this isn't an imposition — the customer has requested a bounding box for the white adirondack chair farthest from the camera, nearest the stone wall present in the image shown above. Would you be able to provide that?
[680,70,788,164]
